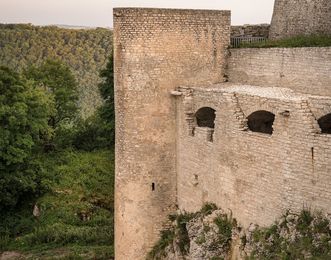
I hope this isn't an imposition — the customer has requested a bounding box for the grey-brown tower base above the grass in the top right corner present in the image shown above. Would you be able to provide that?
[269,0,331,39]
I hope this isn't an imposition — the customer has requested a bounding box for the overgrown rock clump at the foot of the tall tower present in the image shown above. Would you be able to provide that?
[148,204,237,259]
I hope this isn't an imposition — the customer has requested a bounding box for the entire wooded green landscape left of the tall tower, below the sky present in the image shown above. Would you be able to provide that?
[0,25,115,259]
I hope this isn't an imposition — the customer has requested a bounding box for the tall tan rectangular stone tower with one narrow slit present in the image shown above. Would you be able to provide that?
[114,8,230,260]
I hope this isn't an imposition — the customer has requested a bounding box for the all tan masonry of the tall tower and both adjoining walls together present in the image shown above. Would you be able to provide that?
[114,3,331,260]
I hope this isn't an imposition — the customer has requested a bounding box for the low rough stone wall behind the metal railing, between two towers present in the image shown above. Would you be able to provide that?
[231,24,270,38]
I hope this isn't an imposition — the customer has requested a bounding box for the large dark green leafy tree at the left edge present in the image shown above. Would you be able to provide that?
[0,67,52,209]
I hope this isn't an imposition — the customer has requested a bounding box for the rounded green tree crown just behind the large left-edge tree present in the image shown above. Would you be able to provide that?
[24,60,78,129]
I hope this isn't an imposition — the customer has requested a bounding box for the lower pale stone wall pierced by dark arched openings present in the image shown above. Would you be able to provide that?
[177,84,331,226]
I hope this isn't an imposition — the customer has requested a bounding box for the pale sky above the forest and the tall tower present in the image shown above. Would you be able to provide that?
[0,0,274,27]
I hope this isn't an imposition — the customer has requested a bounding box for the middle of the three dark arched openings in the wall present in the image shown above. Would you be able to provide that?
[247,110,275,135]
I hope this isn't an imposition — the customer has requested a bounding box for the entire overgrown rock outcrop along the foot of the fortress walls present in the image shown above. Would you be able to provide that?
[149,204,331,259]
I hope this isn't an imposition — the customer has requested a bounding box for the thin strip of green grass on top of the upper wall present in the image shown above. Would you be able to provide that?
[240,35,331,48]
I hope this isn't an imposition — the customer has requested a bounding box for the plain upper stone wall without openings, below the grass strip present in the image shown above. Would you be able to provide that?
[228,47,331,96]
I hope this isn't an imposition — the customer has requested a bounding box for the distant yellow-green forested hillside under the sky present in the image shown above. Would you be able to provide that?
[0,24,112,117]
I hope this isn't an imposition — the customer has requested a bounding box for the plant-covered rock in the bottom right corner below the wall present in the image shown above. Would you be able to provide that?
[250,209,331,259]
